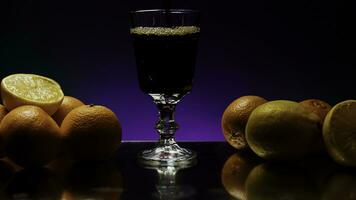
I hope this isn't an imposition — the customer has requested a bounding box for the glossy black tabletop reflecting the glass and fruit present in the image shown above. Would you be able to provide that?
[0,142,356,200]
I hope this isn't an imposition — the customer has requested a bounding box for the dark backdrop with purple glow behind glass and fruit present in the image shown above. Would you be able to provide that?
[0,0,356,140]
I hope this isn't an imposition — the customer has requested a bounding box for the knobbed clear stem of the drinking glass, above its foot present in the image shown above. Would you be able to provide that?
[156,104,179,142]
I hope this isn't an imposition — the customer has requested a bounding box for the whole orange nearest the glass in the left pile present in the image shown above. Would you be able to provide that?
[61,105,121,160]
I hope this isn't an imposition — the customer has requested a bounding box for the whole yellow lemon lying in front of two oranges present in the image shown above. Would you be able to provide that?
[246,100,322,160]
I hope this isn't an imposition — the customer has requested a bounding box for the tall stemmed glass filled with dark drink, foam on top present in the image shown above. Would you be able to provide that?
[130,9,200,166]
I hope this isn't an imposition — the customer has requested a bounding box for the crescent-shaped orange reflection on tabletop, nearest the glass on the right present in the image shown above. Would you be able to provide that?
[221,152,259,200]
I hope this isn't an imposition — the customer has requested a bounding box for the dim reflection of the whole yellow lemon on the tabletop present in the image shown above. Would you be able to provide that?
[246,163,319,200]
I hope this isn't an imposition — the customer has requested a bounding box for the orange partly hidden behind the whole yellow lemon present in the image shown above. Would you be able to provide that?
[221,96,267,149]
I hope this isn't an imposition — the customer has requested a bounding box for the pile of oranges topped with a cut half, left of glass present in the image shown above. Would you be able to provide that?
[0,74,122,168]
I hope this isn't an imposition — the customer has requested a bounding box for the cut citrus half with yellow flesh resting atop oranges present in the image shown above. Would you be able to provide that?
[1,74,64,115]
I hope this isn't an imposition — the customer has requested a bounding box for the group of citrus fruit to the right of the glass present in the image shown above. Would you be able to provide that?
[221,96,356,166]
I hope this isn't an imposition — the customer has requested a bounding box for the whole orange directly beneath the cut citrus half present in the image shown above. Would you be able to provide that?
[0,105,60,167]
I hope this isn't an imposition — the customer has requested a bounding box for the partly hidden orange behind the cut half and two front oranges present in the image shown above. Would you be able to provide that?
[52,96,84,126]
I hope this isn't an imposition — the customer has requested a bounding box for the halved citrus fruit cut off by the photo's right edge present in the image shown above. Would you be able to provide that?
[323,100,356,166]
